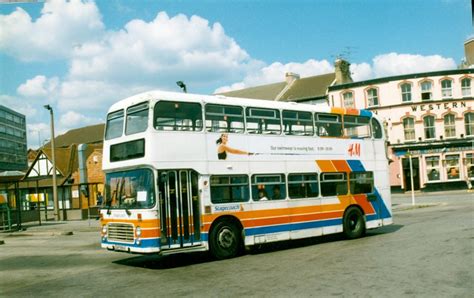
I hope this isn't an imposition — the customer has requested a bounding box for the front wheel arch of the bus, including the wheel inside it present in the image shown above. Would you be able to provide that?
[209,215,243,260]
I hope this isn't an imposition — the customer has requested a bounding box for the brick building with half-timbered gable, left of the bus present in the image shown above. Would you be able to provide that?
[3,124,104,222]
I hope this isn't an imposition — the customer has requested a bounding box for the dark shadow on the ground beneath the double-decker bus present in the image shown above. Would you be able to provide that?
[113,225,403,270]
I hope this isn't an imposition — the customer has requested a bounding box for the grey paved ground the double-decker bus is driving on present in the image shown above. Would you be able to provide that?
[0,191,474,297]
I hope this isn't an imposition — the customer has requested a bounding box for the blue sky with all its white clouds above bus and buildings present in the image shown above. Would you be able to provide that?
[0,0,473,149]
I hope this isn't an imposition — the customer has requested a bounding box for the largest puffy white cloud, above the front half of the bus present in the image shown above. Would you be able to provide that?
[69,12,259,88]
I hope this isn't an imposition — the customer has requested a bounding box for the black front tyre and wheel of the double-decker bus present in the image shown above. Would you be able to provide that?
[209,221,241,260]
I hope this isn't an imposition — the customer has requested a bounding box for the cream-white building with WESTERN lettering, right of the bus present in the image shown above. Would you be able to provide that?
[328,68,474,190]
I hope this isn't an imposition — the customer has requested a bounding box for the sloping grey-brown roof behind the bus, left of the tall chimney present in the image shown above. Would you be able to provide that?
[220,73,336,101]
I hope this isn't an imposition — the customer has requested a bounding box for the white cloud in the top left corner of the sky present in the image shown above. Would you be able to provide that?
[0,0,104,61]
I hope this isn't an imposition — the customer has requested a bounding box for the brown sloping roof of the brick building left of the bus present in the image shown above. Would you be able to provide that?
[43,123,105,148]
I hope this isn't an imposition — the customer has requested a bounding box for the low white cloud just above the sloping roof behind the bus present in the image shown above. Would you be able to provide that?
[214,59,334,93]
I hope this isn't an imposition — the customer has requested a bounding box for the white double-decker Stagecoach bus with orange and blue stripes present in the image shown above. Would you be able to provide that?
[100,91,392,259]
